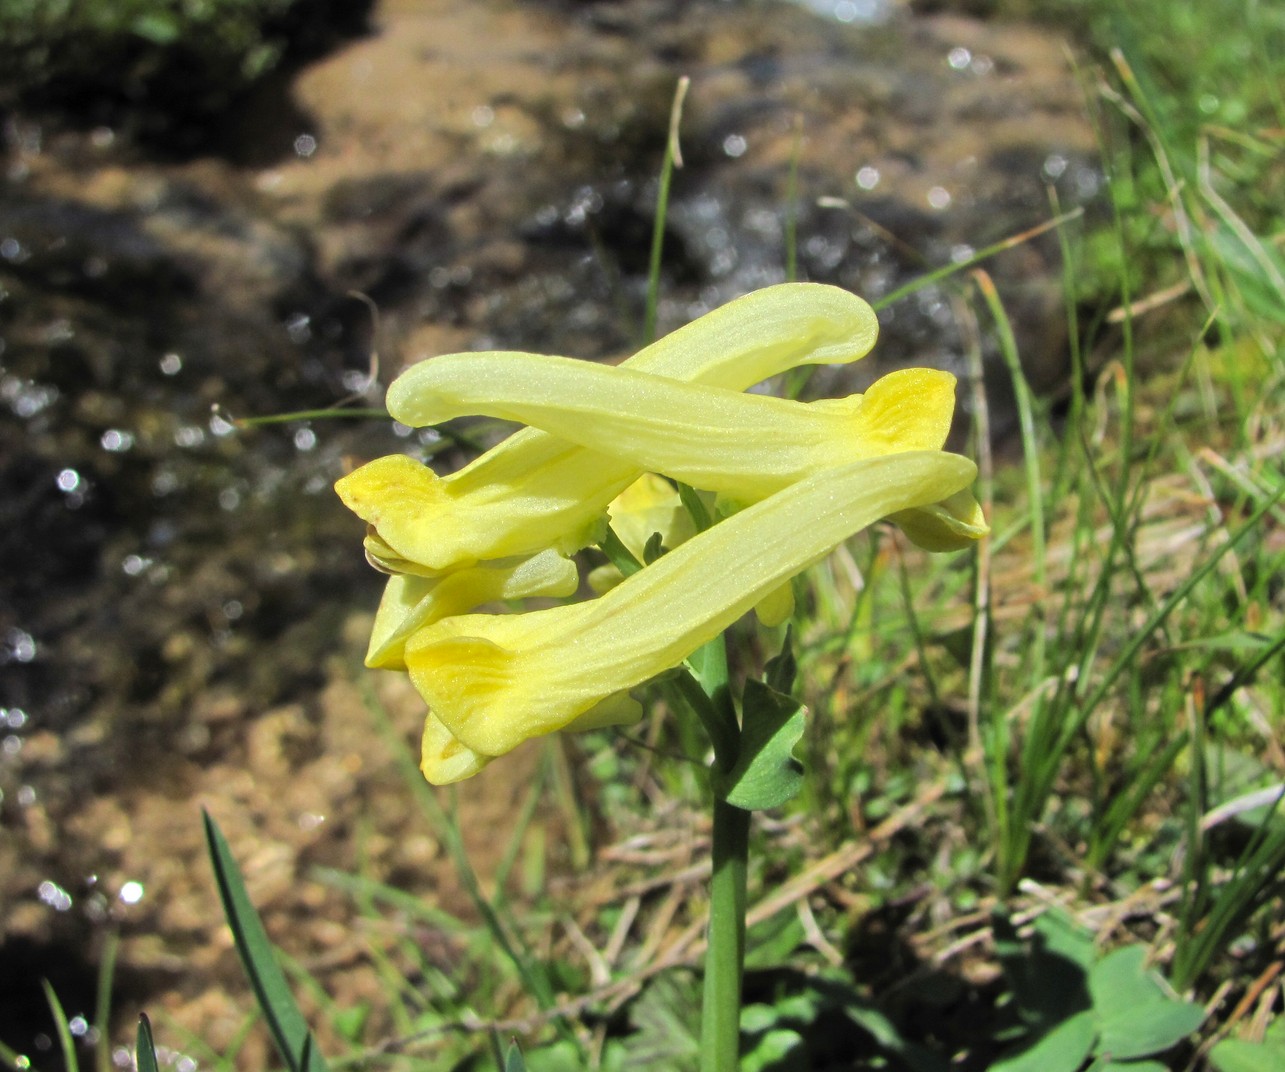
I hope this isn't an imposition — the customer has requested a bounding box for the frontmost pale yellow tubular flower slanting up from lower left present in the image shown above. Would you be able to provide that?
[405,451,977,757]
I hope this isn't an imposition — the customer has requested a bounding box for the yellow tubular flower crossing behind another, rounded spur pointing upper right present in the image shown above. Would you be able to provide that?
[335,283,878,576]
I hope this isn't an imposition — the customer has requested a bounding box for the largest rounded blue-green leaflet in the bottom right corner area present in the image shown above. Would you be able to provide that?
[1088,945,1204,1060]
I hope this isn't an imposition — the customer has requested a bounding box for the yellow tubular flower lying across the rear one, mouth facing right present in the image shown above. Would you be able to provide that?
[388,352,986,549]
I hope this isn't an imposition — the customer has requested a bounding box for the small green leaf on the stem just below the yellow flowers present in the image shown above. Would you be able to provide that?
[713,681,804,811]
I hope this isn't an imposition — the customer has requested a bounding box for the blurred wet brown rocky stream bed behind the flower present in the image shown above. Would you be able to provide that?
[0,0,1279,1067]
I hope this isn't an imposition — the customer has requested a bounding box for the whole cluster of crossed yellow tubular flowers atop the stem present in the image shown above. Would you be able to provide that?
[335,283,987,784]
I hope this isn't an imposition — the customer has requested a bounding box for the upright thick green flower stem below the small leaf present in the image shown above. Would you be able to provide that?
[700,800,749,1072]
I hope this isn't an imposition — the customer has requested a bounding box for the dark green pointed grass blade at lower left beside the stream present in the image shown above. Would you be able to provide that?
[200,808,326,1072]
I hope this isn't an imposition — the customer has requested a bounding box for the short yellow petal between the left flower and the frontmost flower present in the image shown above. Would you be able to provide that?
[366,551,580,670]
